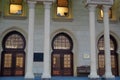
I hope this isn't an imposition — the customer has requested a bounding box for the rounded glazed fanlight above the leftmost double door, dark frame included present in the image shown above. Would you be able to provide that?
[3,31,25,50]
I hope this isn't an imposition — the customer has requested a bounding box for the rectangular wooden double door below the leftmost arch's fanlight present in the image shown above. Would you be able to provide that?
[1,52,25,76]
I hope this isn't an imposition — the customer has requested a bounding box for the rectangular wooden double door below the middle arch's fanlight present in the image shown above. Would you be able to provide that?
[51,51,73,76]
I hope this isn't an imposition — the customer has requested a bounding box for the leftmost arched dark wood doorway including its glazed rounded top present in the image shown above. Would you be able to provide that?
[1,31,26,76]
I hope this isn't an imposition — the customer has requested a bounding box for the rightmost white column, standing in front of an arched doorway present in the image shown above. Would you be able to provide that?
[103,5,114,78]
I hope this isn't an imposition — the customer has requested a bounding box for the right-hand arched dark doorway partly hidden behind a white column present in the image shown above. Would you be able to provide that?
[98,35,118,76]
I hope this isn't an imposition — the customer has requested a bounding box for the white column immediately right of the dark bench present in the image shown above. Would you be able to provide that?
[88,4,99,78]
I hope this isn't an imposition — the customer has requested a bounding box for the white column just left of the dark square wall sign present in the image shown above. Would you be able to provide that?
[25,1,36,79]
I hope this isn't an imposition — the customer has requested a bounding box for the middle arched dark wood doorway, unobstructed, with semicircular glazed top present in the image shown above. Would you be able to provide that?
[51,33,73,76]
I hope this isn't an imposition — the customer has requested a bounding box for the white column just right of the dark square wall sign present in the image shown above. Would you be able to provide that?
[42,2,52,79]
